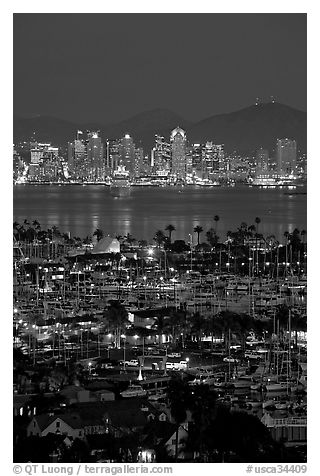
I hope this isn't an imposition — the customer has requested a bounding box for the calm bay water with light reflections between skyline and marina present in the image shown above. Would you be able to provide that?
[13,185,307,242]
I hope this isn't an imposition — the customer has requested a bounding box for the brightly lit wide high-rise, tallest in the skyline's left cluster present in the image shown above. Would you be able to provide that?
[86,131,105,181]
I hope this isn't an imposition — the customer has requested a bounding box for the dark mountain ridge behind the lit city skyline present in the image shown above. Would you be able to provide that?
[13,102,307,153]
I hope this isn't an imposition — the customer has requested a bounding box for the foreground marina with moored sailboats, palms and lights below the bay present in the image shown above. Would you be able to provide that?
[13,217,307,462]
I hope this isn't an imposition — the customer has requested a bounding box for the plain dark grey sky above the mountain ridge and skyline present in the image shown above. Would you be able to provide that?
[13,13,307,123]
